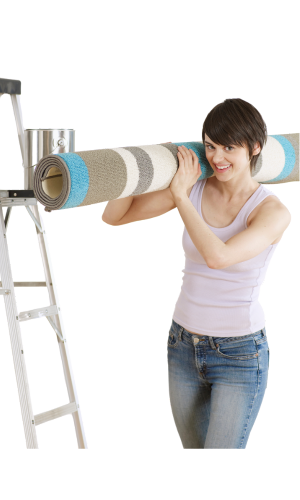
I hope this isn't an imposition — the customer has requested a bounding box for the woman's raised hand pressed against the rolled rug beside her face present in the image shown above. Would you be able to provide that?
[170,146,202,198]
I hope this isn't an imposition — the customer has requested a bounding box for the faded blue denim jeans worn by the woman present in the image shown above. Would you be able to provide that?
[167,320,270,450]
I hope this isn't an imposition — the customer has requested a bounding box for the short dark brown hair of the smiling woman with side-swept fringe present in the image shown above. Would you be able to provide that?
[201,97,268,176]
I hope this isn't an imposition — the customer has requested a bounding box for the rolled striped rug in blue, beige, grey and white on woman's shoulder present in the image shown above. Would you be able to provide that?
[33,136,300,212]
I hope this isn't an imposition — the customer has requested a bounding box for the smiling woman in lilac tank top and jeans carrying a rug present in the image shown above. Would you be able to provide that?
[167,98,291,449]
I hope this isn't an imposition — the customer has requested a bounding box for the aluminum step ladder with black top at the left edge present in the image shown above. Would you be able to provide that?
[0,78,89,449]
